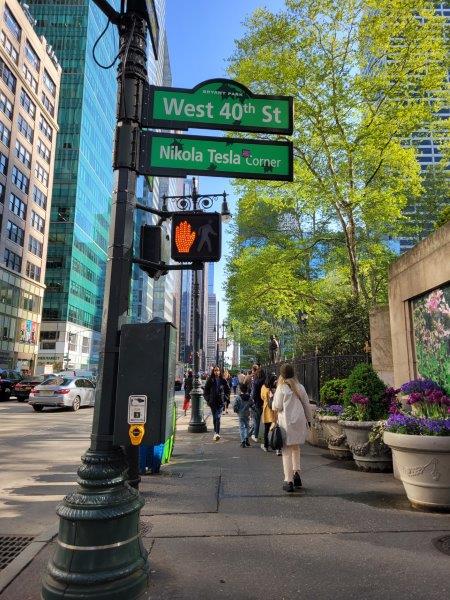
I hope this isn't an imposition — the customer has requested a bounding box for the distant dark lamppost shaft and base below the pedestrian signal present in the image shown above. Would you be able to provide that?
[188,262,207,433]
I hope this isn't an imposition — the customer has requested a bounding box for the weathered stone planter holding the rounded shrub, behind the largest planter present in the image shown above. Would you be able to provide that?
[339,421,392,472]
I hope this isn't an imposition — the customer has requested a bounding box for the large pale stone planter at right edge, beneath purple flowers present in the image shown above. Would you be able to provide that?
[383,431,450,511]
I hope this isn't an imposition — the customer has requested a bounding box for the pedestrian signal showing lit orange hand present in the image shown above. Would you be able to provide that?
[172,212,222,262]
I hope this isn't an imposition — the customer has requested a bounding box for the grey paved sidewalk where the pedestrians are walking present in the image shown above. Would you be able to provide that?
[1,414,450,600]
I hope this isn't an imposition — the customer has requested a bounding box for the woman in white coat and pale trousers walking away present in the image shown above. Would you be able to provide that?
[272,364,312,492]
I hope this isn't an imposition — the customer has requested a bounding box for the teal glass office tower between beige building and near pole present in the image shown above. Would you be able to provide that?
[25,0,119,371]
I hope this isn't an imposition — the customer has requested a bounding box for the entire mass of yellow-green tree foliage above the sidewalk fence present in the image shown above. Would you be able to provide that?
[227,0,449,354]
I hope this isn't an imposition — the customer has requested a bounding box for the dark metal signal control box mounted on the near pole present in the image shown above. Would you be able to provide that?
[114,318,176,446]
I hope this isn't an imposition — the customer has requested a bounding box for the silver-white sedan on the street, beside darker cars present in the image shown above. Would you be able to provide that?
[28,377,95,412]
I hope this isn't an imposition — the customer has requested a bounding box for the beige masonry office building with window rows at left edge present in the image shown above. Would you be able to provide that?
[0,0,61,371]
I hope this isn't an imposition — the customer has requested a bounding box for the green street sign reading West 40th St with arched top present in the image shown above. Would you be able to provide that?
[141,79,293,135]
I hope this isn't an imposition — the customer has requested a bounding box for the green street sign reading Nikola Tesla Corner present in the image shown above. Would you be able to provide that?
[139,131,293,181]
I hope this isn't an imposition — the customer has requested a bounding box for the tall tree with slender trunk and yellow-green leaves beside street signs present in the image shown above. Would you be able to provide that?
[229,0,446,297]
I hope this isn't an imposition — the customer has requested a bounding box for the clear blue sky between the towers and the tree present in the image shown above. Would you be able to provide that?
[166,0,284,320]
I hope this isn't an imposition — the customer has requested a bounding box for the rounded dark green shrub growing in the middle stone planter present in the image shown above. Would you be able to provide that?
[344,363,389,421]
